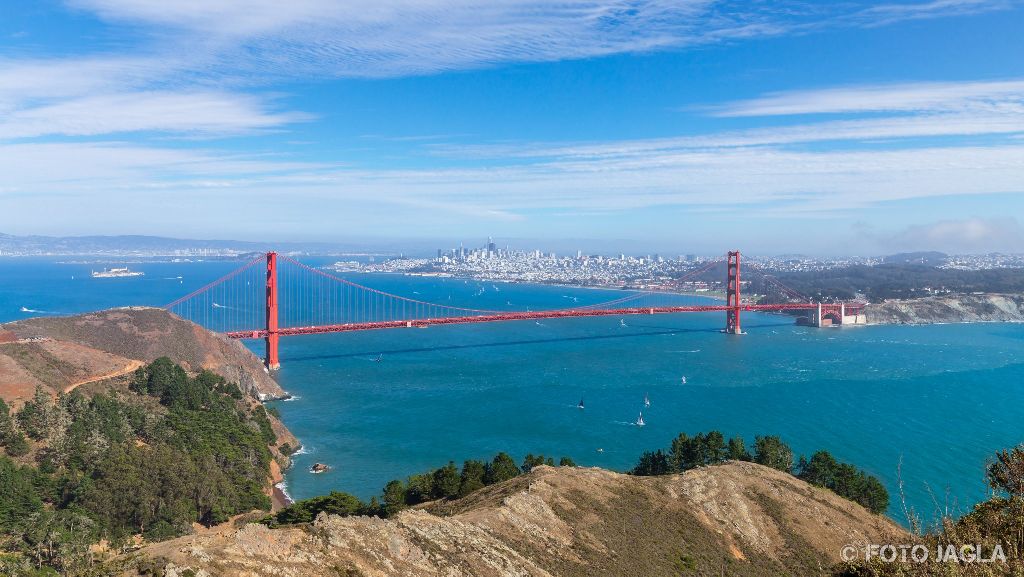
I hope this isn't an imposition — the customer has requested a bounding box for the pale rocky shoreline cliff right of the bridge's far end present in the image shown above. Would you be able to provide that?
[864,294,1024,325]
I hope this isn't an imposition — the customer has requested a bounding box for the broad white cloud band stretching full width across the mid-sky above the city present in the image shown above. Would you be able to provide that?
[0,143,1024,215]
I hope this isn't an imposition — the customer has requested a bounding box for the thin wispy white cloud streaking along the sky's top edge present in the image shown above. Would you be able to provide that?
[70,0,1008,77]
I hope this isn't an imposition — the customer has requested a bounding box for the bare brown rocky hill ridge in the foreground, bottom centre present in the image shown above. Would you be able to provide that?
[134,462,908,577]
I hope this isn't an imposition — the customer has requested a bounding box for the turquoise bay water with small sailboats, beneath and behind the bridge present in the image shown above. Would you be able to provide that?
[0,259,1024,521]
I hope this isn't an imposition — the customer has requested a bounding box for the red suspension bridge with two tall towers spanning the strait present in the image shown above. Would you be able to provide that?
[165,251,863,369]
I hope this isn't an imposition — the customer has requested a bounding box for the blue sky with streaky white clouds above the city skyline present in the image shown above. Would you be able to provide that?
[0,0,1024,254]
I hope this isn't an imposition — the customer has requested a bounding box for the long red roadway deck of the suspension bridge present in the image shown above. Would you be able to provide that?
[224,302,831,338]
